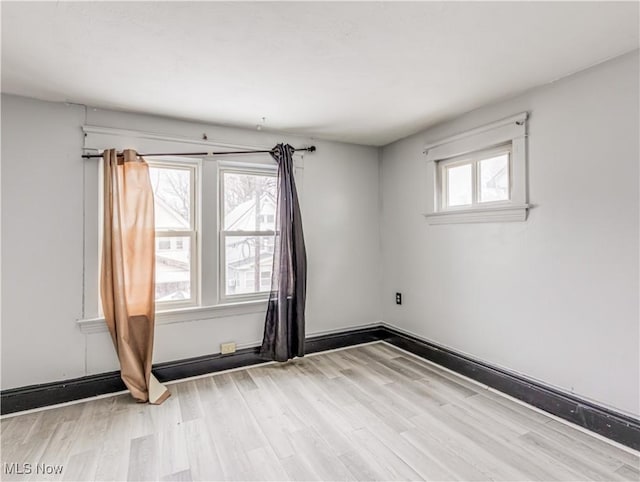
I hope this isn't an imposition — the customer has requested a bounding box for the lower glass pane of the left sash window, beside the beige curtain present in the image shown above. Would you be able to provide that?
[156,236,191,301]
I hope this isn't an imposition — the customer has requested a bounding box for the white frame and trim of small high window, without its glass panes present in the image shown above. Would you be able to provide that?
[424,112,529,224]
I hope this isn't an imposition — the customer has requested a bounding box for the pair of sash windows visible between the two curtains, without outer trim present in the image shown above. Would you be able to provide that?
[147,158,276,311]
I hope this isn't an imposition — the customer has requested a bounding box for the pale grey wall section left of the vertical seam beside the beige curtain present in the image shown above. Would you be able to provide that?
[2,96,85,388]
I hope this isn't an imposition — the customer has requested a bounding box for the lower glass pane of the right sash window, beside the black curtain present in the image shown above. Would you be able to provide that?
[225,236,274,296]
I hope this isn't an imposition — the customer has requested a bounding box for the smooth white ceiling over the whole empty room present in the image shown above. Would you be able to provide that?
[1,2,639,145]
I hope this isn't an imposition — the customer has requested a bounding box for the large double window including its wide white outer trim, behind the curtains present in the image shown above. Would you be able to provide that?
[79,126,288,333]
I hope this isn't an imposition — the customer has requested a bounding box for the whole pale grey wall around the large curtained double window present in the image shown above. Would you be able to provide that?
[1,96,381,389]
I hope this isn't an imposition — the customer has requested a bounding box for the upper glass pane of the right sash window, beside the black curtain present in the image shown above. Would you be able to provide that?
[223,172,276,231]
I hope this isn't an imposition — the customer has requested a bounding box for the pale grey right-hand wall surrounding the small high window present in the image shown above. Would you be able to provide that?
[381,52,640,416]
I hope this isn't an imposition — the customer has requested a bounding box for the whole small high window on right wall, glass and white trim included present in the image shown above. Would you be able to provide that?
[425,112,529,224]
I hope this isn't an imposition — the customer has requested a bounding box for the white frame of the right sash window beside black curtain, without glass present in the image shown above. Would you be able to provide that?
[218,166,277,303]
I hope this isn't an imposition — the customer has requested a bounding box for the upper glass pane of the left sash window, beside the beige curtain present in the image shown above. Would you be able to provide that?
[149,166,192,230]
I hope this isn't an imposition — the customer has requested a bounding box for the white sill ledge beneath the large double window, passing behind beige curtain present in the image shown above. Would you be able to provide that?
[77,300,267,334]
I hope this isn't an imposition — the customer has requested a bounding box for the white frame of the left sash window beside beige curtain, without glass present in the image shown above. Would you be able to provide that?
[145,157,201,311]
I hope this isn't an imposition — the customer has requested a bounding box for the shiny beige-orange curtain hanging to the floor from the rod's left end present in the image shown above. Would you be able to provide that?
[100,149,170,404]
